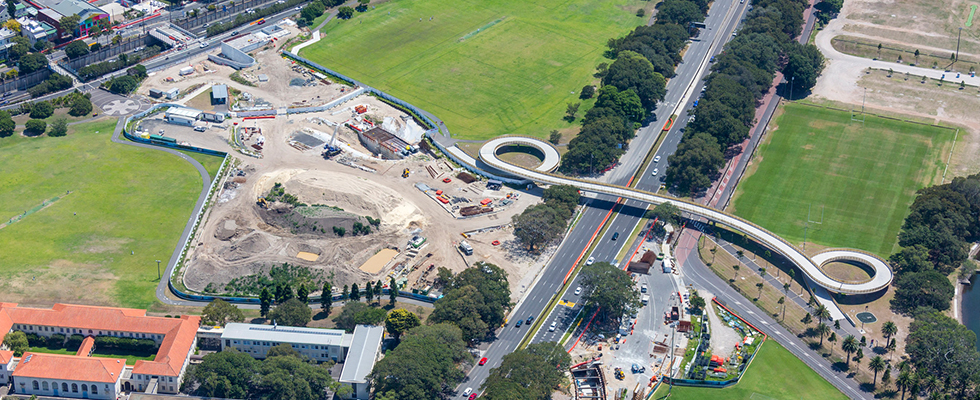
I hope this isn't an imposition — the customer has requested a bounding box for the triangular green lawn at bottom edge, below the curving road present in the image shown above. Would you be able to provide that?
[653,340,847,400]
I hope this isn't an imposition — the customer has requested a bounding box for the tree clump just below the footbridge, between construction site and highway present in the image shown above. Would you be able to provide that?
[512,185,581,252]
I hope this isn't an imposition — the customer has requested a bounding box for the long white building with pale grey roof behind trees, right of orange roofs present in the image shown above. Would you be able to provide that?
[221,323,351,362]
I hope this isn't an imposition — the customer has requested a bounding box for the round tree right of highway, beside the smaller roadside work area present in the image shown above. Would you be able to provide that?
[579,262,642,324]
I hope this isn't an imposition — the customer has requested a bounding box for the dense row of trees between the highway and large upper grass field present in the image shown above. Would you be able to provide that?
[561,14,707,175]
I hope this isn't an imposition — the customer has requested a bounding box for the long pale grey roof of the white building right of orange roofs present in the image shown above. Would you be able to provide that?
[221,323,350,346]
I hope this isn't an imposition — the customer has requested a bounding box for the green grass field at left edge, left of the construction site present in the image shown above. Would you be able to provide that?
[0,119,220,308]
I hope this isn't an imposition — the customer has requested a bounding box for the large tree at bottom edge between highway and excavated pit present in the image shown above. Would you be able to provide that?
[480,342,572,400]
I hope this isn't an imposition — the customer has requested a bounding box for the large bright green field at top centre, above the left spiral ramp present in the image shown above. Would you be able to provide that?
[300,0,656,139]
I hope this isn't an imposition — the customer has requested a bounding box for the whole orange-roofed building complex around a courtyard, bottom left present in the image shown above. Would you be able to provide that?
[0,303,201,398]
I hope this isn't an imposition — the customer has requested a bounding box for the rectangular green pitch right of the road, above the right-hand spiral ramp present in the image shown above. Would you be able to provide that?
[732,104,955,257]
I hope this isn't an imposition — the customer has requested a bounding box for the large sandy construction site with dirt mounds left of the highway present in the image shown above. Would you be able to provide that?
[134,41,554,301]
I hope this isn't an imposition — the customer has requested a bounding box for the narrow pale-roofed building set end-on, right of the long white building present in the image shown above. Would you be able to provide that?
[338,325,385,400]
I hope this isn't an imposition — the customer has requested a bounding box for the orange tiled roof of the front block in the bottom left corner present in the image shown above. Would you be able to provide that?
[12,352,126,383]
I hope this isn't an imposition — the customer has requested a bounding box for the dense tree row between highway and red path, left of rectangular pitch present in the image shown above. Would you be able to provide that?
[666,0,823,195]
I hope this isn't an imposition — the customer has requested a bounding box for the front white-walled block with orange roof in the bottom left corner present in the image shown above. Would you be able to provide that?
[11,353,126,399]
